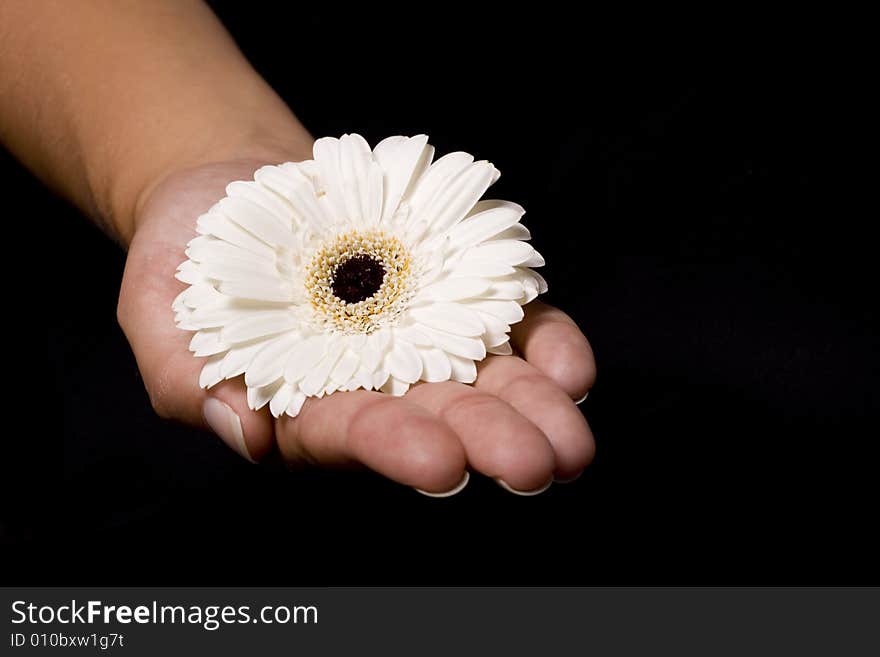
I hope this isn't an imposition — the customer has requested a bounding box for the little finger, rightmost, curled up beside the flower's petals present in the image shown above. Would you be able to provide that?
[511,301,596,399]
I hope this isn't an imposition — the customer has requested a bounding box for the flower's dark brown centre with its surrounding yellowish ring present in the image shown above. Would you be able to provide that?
[305,230,416,334]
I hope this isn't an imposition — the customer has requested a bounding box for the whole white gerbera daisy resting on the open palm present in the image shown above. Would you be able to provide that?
[173,135,547,417]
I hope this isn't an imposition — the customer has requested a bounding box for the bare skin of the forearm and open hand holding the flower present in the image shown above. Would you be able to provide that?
[0,0,595,493]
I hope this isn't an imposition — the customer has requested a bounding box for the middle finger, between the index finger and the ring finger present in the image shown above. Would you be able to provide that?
[406,381,552,491]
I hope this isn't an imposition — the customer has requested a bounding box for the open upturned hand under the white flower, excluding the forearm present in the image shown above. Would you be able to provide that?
[118,157,595,494]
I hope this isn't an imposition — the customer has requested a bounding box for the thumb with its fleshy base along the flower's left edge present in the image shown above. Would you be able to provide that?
[117,243,274,461]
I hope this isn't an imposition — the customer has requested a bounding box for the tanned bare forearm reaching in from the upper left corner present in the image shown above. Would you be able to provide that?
[0,0,311,243]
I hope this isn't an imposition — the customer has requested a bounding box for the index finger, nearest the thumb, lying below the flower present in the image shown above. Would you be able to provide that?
[276,390,467,493]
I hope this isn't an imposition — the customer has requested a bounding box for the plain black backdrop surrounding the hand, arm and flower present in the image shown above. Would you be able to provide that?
[0,2,878,585]
